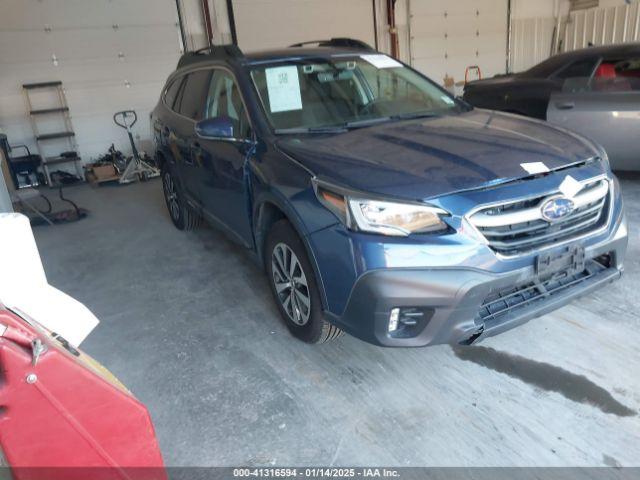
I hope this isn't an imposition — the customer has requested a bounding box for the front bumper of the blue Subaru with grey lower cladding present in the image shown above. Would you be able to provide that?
[328,208,627,347]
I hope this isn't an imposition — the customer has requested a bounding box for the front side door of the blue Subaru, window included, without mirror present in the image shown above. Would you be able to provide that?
[197,68,255,245]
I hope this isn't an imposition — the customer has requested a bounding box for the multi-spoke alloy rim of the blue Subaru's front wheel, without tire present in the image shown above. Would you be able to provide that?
[271,243,311,326]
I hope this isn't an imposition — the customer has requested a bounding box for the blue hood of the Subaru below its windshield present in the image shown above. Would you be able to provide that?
[277,109,598,200]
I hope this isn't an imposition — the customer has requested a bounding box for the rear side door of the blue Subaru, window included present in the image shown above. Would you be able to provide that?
[171,69,212,203]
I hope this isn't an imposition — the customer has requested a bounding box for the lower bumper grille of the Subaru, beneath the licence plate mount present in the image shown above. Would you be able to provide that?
[478,260,607,323]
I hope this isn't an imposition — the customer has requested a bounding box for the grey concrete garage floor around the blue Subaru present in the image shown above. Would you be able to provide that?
[35,172,640,466]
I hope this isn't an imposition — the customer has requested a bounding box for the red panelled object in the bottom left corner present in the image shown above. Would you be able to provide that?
[0,305,167,480]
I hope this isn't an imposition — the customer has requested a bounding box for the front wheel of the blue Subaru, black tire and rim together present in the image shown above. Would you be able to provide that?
[265,220,343,343]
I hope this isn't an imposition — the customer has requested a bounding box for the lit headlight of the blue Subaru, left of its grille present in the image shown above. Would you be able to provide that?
[316,182,449,237]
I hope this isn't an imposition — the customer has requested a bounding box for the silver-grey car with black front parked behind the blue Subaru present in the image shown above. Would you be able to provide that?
[464,43,640,171]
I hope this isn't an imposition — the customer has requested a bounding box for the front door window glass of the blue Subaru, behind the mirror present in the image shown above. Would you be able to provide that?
[205,70,251,139]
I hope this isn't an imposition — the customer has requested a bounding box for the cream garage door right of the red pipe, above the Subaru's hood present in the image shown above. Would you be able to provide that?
[409,0,507,83]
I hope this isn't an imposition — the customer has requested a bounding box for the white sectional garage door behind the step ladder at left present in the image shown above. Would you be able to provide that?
[0,0,180,161]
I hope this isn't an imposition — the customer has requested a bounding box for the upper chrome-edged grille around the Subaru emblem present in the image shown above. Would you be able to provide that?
[470,179,609,255]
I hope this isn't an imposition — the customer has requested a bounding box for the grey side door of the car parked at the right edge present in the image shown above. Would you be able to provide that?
[547,61,640,171]
